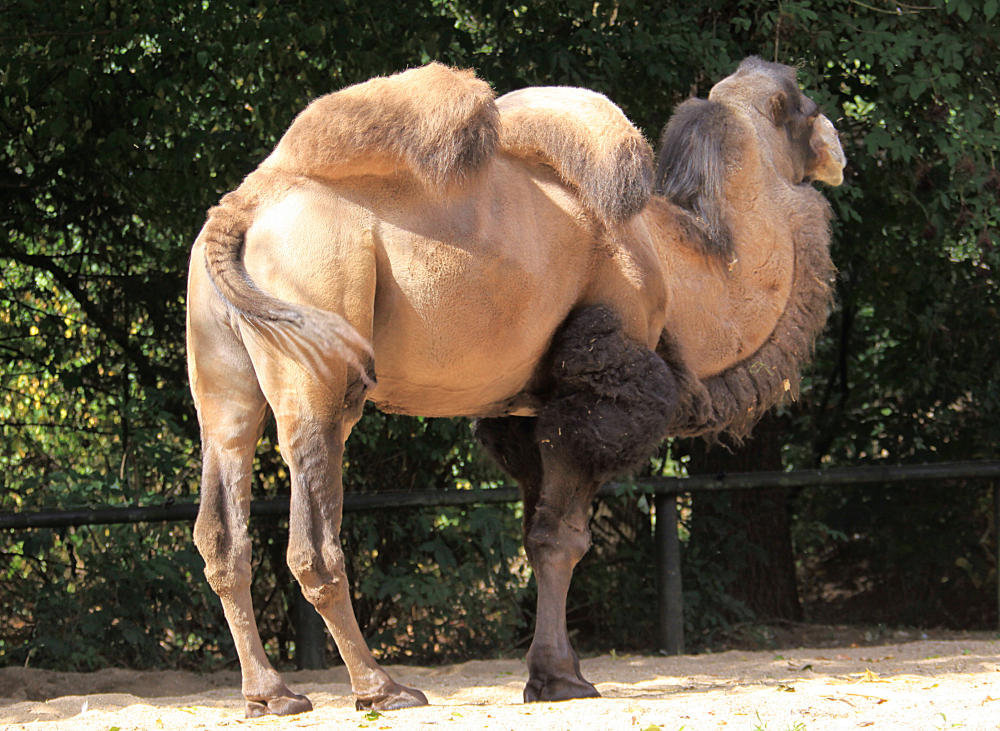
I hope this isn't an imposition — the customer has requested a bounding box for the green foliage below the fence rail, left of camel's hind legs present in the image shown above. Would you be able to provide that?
[0,525,231,670]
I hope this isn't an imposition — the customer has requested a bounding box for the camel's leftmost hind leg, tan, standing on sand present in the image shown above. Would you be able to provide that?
[189,317,312,717]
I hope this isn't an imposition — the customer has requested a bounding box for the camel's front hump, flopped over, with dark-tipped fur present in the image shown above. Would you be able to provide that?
[496,86,653,225]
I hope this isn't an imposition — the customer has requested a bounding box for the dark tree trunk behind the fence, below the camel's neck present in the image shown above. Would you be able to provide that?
[686,414,802,621]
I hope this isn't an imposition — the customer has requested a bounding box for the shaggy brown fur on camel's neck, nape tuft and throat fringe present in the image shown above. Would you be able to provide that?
[651,100,834,439]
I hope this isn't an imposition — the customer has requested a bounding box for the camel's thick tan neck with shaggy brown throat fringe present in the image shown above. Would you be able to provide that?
[643,166,833,435]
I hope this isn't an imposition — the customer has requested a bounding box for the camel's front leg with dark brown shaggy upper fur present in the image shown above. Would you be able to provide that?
[477,307,677,701]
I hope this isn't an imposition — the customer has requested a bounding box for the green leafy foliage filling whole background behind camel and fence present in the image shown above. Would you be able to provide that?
[0,0,1000,667]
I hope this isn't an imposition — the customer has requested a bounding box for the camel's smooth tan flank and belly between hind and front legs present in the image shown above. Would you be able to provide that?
[370,179,594,416]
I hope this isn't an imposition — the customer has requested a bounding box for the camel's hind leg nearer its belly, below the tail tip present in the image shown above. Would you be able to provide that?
[251,349,427,710]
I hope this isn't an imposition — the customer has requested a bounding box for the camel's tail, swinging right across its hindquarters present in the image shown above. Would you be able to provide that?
[200,191,374,387]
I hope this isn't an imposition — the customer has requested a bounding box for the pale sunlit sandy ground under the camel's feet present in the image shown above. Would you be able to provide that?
[0,638,1000,731]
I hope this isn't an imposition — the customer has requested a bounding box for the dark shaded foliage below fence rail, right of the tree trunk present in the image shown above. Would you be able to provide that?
[793,484,997,628]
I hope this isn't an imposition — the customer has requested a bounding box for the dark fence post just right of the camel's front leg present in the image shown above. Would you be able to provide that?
[654,493,684,655]
